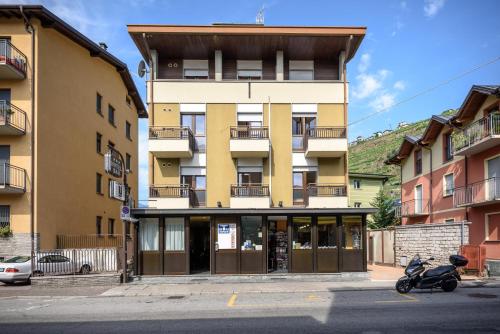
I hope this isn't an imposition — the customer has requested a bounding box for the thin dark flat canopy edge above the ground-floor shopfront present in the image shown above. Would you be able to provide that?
[131,208,377,218]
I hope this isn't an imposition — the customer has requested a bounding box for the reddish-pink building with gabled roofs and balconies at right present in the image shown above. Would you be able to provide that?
[388,86,500,262]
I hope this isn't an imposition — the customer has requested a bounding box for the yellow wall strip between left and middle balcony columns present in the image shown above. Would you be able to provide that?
[206,104,237,207]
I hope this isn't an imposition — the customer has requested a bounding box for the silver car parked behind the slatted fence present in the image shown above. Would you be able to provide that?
[33,254,92,276]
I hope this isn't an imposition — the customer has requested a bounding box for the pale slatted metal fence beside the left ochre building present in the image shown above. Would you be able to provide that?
[33,248,121,276]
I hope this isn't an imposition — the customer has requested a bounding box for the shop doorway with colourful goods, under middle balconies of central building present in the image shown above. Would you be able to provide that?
[267,217,289,273]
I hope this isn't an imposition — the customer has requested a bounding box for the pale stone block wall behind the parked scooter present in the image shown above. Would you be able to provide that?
[395,222,470,265]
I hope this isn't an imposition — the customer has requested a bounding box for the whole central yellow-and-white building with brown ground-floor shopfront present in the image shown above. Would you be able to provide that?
[128,24,370,274]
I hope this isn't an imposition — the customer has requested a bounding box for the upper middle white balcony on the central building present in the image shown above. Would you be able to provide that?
[229,126,269,158]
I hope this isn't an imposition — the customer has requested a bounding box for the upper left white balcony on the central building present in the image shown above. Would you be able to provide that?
[149,127,195,158]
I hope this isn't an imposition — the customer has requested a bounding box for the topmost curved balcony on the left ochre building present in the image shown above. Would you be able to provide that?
[0,39,27,80]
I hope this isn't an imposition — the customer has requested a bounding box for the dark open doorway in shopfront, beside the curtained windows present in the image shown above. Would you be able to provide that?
[189,218,210,274]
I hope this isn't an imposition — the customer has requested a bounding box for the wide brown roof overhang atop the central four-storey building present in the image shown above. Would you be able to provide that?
[128,24,366,61]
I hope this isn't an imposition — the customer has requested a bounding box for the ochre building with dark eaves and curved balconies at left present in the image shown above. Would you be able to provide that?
[0,5,147,255]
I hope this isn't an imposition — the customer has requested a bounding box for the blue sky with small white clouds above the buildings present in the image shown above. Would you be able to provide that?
[0,0,500,200]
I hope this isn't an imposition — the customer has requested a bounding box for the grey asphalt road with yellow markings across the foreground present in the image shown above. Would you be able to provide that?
[0,288,500,334]
